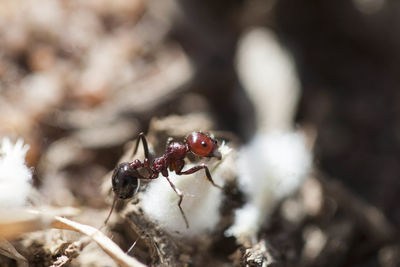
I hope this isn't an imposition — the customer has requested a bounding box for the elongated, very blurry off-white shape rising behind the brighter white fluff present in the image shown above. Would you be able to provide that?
[236,28,300,131]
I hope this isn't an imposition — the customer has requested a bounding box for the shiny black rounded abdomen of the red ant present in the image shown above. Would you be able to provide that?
[112,163,140,199]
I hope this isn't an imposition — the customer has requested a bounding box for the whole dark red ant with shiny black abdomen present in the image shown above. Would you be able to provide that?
[104,132,222,228]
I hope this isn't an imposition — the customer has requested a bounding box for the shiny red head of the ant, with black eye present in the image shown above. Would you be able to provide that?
[186,132,221,159]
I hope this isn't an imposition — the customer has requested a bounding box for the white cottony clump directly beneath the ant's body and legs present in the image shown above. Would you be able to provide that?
[140,145,230,237]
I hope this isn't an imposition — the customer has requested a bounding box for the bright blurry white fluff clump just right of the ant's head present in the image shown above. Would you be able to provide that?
[226,133,311,242]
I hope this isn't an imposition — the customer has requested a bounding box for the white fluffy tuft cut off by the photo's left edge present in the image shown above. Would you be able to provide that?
[0,138,32,208]
